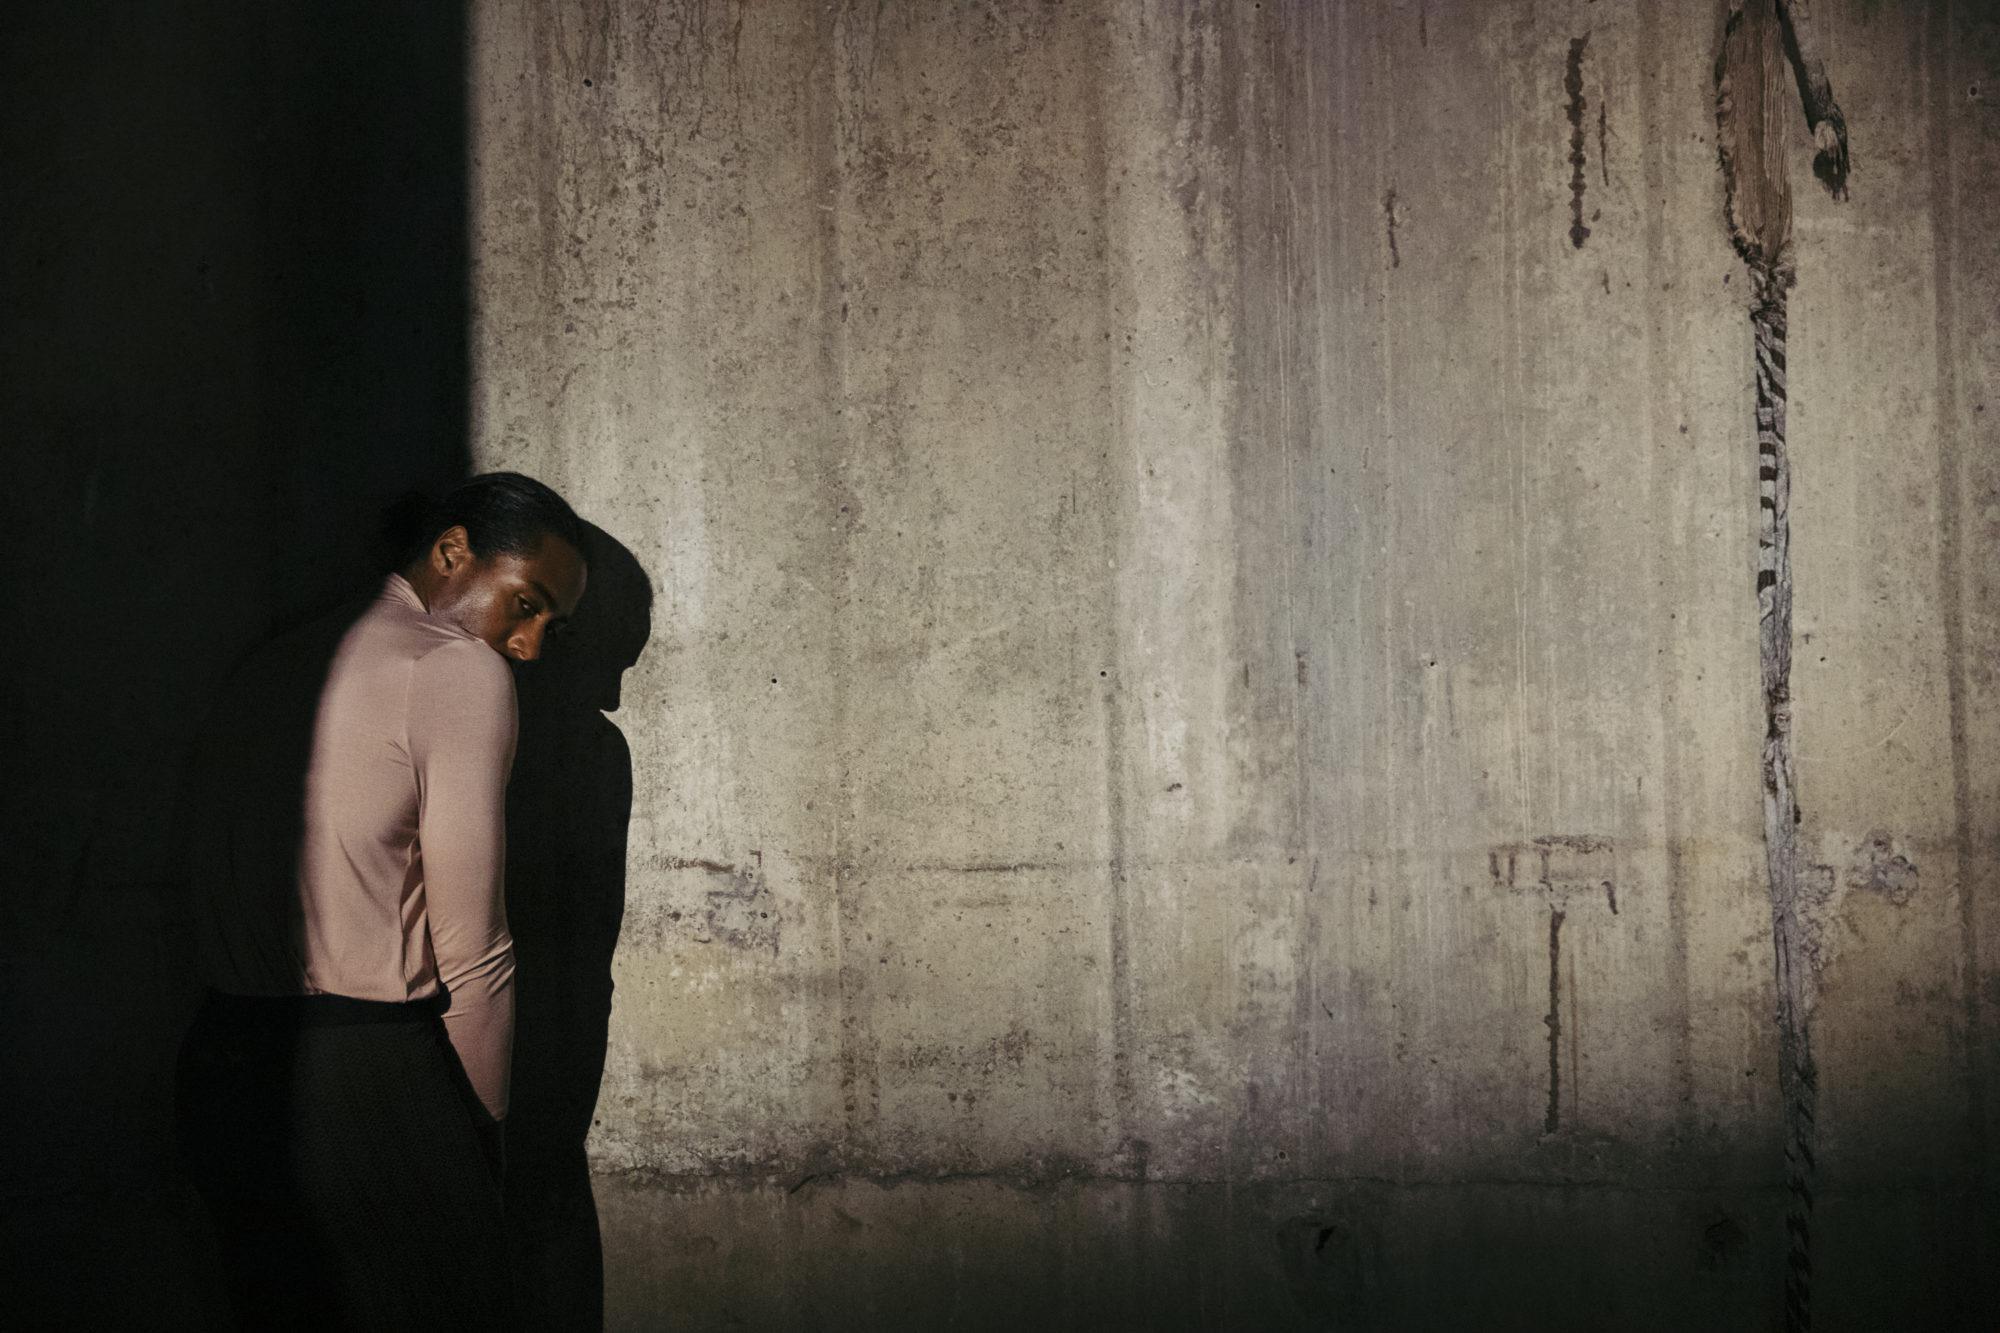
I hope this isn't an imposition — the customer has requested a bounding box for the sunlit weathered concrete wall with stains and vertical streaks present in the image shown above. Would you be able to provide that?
[470,0,2000,1327]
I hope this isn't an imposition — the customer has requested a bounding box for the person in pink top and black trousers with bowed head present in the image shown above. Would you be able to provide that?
[176,472,588,1331]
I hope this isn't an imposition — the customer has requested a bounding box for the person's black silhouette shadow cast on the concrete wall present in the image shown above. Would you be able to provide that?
[506,524,652,1329]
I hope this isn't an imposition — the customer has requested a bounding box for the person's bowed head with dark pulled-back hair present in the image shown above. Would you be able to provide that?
[390,472,588,662]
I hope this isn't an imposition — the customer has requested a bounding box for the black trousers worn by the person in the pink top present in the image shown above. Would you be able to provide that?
[176,991,512,1333]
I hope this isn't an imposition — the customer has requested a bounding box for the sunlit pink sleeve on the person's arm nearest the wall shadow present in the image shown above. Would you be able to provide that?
[406,640,516,1119]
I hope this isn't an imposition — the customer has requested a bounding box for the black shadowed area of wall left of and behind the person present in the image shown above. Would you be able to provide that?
[0,0,466,1329]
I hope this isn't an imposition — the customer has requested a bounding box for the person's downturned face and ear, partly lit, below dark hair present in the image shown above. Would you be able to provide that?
[418,528,588,662]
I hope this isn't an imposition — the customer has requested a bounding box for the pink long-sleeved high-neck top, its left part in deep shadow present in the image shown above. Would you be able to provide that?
[190,574,516,1119]
